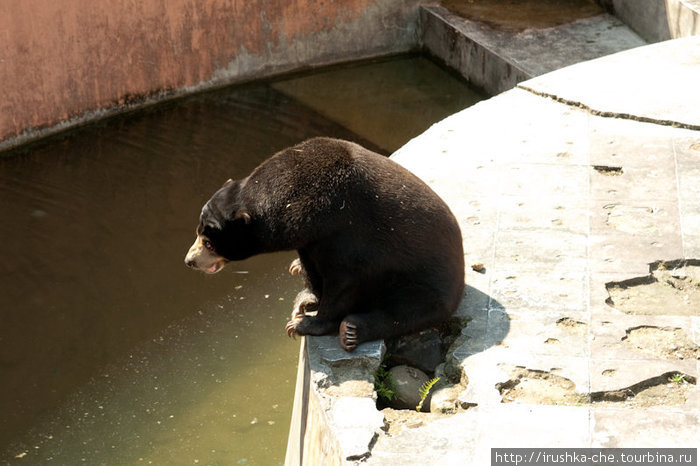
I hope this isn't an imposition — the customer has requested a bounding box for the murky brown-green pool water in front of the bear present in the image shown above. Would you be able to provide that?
[0,57,484,465]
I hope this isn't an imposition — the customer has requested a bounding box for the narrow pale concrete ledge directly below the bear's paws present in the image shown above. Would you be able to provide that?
[285,336,385,466]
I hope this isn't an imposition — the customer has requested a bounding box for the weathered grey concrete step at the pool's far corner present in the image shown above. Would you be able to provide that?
[420,6,647,95]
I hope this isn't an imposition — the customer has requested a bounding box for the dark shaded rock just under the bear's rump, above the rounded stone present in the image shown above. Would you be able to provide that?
[386,329,445,373]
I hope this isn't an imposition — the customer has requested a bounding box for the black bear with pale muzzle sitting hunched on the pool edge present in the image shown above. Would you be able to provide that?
[185,138,465,351]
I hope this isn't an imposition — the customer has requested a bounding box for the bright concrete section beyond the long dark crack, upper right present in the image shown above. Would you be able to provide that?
[521,36,700,129]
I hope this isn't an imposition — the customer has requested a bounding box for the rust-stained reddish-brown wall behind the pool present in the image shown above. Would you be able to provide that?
[0,0,420,150]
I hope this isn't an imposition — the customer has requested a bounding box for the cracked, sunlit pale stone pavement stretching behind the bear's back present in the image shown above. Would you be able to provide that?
[362,37,700,465]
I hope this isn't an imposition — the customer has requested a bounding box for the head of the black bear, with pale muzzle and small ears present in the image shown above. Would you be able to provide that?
[185,180,258,273]
